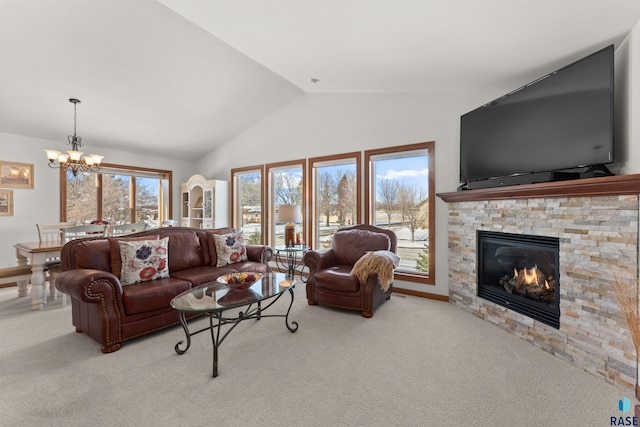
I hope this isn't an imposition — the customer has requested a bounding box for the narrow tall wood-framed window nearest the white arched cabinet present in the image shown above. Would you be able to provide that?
[231,166,264,244]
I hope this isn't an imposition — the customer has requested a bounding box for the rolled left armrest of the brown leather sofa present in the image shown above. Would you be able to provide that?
[56,268,122,306]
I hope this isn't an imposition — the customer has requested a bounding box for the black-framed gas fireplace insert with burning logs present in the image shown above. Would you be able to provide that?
[477,234,560,329]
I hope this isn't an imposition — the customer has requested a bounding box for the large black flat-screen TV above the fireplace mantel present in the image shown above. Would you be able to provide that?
[459,45,613,190]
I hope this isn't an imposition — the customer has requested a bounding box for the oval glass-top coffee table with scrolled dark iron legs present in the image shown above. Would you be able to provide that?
[171,273,298,377]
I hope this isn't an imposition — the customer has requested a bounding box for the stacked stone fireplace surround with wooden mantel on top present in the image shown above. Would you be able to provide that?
[438,175,640,389]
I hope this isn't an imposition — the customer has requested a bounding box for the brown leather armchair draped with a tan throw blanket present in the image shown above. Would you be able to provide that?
[304,224,398,318]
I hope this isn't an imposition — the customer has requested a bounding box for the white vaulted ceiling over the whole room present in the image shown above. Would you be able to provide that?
[0,0,640,160]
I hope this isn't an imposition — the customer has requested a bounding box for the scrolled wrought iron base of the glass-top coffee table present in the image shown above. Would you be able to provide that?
[175,288,298,377]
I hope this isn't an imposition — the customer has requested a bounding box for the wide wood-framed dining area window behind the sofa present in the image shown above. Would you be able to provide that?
[60,164,171,227]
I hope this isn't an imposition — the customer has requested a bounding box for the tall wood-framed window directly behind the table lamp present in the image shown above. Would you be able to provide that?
[266,160,306,247]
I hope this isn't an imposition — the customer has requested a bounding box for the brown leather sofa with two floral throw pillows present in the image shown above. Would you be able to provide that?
[56,227,273,353]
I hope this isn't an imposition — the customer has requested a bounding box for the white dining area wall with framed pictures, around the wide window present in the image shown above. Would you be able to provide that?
[0,133,193,268]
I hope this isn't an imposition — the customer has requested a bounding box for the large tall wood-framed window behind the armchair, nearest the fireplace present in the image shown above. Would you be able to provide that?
[365,142,435,283]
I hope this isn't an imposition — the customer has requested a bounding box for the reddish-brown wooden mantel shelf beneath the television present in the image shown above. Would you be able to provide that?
[436,174,640,203]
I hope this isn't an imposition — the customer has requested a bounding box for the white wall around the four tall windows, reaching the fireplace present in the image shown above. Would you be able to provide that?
[196,93,498,295]
